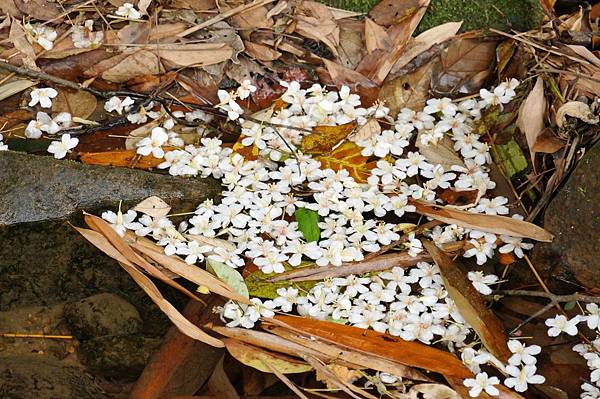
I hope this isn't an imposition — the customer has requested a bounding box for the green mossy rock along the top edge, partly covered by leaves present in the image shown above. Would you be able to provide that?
[321,0,542,33]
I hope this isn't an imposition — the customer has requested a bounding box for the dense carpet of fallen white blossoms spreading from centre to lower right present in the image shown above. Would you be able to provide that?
[82,76,600,398]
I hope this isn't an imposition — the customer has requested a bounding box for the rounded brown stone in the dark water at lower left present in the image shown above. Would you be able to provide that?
[64,293,142,339]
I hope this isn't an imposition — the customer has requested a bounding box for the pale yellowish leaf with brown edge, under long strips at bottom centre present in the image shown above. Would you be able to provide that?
[223,338,312,374]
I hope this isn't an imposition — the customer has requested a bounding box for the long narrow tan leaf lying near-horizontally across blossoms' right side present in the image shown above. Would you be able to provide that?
[410,200,554,242]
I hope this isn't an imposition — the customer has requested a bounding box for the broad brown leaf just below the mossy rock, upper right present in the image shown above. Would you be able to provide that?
[431,37,497,95]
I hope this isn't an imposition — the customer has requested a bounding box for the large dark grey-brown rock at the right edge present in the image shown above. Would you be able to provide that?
[533,144,600,290]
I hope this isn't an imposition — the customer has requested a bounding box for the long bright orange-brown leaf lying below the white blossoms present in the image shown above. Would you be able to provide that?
[275,315,473,378]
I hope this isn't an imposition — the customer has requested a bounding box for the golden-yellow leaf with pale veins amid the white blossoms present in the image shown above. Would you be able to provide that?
[317,141,376,183]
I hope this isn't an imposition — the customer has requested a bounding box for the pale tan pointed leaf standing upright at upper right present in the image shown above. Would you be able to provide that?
[517,76,546,153]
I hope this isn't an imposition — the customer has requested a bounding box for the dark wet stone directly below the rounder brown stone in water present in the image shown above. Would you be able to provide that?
[79,335,162,381]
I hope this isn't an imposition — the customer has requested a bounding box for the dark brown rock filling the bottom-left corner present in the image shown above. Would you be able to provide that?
[0,356,108,399]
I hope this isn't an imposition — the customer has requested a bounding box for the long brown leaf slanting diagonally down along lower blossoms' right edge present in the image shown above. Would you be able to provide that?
[422,240,511,363]
